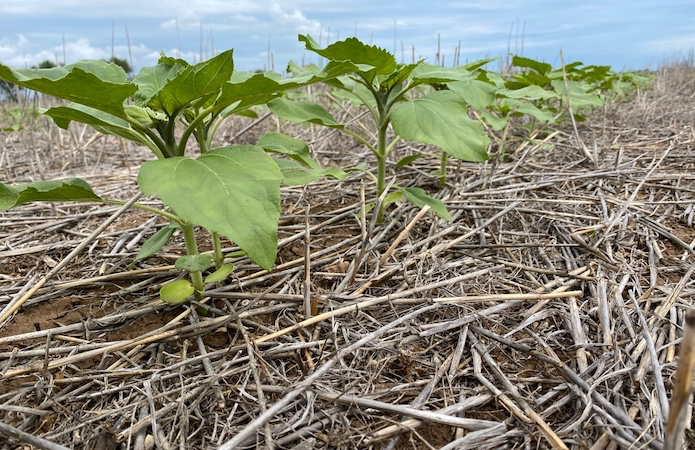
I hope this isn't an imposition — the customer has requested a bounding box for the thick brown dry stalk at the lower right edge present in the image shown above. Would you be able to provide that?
[664,310,695,450]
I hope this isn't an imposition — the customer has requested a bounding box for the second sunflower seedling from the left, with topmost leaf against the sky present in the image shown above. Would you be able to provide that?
[268,35,489,220]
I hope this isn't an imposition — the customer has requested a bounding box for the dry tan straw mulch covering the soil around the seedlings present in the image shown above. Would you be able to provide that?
[0,66,695,450]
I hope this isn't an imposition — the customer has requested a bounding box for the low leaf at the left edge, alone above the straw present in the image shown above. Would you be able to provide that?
[0,178,101,211]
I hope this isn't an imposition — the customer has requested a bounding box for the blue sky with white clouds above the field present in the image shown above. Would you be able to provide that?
[0,0,695,71]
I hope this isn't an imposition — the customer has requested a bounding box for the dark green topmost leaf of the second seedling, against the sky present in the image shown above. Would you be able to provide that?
[299,34,396,83]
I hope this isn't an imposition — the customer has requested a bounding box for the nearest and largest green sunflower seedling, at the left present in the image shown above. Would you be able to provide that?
[0,50,352,303]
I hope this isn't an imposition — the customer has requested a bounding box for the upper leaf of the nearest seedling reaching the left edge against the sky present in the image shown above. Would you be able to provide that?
[0,60,137,117]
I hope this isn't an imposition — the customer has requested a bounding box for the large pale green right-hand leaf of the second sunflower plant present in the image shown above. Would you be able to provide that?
[391,91,490,161]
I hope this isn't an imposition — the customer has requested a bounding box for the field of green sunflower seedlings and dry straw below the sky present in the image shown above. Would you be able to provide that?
[0,36,695,450]
